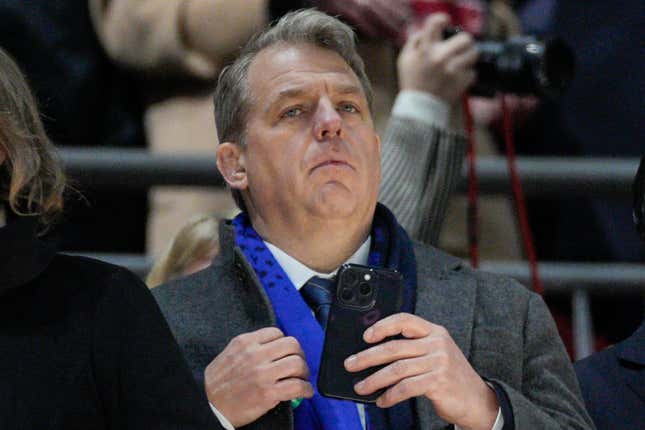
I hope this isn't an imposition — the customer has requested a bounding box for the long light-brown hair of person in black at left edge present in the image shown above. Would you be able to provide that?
[0,49,65,226]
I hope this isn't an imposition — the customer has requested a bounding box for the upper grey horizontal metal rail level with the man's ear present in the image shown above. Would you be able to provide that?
[61,147,639,198]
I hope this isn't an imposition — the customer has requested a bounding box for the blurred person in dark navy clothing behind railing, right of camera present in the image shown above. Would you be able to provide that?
[516,0,645,348]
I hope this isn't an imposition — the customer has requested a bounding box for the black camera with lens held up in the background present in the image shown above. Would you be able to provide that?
[444,27,575,98]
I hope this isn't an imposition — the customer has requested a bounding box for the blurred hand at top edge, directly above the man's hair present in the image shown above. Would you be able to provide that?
[315,0,412,39]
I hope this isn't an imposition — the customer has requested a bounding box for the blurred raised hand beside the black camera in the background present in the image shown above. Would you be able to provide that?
[397,13,478,106]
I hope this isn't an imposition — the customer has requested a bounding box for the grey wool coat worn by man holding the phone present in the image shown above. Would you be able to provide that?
[152,225,594,430]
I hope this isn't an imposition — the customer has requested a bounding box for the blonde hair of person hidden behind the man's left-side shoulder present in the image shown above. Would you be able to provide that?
[146,215,220,288]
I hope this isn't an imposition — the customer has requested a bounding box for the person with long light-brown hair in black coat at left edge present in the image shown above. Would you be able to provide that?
[0,50,221,430]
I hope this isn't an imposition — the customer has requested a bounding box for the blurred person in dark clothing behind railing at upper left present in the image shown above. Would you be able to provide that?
[0,0,148,253]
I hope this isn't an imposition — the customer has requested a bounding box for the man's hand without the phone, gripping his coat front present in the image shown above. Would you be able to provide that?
[204,327,314,428]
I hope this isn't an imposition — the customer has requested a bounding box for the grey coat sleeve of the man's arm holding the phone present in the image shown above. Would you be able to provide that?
[494,294,595,430]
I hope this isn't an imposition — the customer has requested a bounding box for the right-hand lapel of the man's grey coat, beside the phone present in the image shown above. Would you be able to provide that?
[415,247,477,430]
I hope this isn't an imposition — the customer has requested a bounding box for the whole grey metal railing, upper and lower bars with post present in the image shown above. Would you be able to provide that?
[61,147,645,358]
